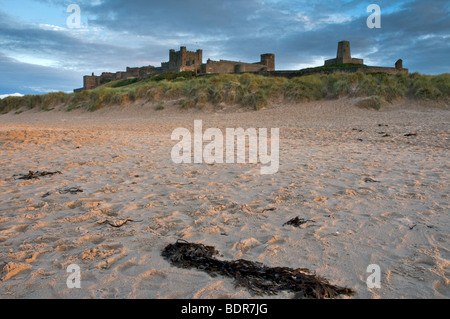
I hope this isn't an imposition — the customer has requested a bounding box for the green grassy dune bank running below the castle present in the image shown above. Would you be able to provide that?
[0,72,450,114]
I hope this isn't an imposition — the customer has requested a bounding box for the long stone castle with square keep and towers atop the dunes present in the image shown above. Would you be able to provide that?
[74,41,408,93]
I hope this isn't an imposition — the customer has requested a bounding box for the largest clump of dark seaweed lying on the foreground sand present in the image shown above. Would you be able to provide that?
[161,240,354,299]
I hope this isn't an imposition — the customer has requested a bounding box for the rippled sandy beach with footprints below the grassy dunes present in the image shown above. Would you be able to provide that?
[0,99,450,298]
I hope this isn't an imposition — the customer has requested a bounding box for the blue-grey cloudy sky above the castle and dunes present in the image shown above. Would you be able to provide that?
[0,0,450,95]
